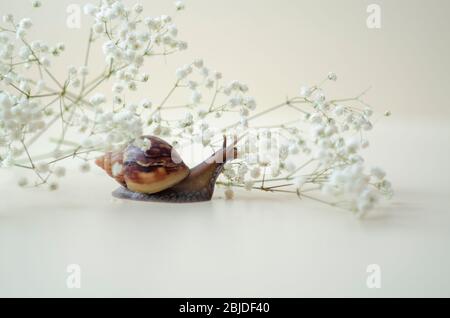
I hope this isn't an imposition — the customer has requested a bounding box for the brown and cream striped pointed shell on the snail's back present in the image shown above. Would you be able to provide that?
[95,136,189,194]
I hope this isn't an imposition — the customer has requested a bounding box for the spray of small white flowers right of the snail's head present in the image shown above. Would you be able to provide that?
[216,73,392,216]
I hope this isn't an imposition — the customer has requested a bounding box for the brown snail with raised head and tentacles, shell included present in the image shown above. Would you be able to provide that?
[95,136,237,202]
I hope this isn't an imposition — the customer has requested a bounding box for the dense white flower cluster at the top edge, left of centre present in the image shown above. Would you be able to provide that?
[84,0,187,93]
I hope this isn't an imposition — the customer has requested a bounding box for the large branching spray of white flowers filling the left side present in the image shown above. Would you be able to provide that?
[0,0,187,190]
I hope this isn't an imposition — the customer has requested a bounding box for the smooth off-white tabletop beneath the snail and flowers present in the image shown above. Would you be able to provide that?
[0,117,450,297]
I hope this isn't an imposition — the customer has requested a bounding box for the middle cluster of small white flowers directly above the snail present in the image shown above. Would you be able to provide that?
[147,59,256,147]
